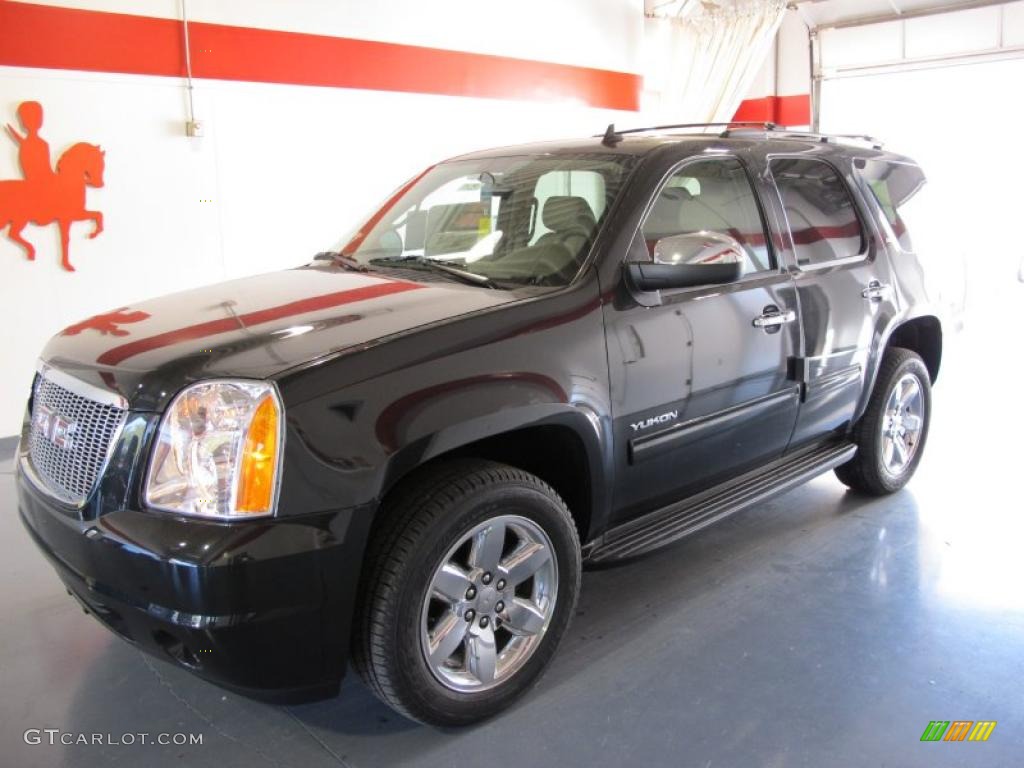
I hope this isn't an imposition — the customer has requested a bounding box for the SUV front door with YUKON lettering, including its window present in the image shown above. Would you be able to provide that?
[605,157,800,522]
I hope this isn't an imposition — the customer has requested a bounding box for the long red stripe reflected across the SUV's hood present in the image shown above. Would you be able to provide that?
[96,281,423,366]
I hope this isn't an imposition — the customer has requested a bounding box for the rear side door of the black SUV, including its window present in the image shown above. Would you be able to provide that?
[767,154,896,447]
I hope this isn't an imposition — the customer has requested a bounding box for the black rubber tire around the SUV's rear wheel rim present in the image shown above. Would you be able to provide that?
[836,347,932,496]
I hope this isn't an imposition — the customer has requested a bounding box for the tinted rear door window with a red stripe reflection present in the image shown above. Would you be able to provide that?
[770,159,864,266]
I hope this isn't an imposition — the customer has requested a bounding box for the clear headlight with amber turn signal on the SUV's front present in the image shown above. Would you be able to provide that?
[145,381,283,518]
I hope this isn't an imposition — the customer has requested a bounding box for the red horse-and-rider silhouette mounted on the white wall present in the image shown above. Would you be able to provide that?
[0,101,103,271]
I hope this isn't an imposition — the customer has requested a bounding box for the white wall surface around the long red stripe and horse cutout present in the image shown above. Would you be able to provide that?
[0,0,643,435]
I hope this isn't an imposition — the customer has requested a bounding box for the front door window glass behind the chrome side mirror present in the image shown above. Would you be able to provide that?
[642,158,771,272]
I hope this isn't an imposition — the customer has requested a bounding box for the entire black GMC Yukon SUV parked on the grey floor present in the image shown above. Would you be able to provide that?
[17,125,942,724]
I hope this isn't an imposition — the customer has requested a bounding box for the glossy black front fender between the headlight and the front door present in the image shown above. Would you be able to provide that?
[279,372,612,521]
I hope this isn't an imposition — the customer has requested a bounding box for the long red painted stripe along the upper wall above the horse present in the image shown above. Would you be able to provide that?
[0,0,642,111]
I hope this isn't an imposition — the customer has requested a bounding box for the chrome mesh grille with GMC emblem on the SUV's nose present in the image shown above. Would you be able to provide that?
[28,369,128,506]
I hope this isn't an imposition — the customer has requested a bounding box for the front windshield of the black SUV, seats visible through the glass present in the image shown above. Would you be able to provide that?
[341,154,632,286]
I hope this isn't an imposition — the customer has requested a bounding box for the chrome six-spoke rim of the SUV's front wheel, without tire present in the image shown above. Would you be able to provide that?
[420,515,558,693]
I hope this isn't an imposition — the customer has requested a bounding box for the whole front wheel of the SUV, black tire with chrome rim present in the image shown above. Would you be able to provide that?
[353,461,581,725]
